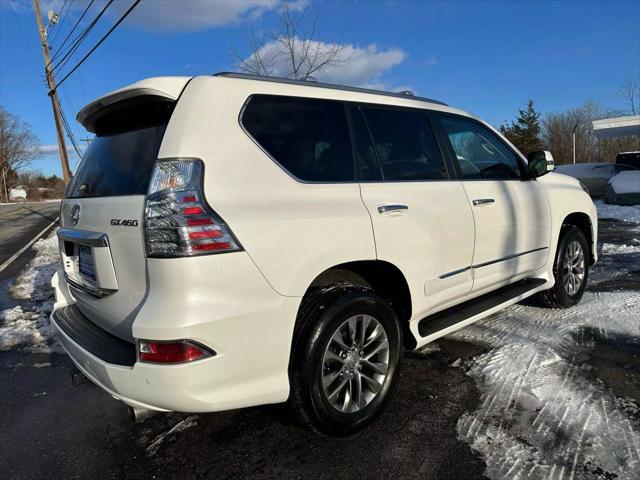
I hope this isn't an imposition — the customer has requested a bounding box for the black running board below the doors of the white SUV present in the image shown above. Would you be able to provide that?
[418,278,546,337]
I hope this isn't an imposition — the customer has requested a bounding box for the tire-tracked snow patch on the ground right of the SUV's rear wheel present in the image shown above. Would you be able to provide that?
[450,291,640,479]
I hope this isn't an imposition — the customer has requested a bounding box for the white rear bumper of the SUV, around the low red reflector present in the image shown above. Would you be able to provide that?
[51,253,300,412]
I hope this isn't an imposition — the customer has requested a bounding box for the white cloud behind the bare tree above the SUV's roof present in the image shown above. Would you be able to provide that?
[240,39,406,89]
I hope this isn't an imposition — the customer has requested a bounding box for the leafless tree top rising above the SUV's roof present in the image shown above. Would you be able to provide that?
[231,1,350,79]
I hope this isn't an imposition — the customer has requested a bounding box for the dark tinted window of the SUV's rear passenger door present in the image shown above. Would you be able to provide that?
[362,106,447,181]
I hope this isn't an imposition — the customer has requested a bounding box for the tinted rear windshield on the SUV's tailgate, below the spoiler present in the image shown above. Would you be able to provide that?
[68,123,167,198]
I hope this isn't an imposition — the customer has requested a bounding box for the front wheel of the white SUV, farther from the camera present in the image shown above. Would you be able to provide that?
[538,225,589,308]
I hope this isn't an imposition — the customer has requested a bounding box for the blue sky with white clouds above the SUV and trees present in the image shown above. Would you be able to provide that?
[0,0,640,175]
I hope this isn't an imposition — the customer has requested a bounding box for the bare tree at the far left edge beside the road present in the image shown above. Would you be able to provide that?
[0,107,38,201]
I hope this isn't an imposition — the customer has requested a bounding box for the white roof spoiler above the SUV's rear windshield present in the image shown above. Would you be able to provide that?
[76,77,192,133]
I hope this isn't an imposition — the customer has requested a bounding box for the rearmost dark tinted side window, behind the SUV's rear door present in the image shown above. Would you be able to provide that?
[242,95,354,182]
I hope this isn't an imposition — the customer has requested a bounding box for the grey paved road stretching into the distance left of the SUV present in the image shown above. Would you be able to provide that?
[0,202,60,280]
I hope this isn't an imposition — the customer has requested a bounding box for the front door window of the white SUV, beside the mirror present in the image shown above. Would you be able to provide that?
[440,116,520,180]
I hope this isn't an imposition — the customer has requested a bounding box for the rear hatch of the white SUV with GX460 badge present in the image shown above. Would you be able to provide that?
[58,78,188,341]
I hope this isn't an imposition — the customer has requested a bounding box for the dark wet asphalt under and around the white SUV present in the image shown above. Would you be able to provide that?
[0,221,640,480]
